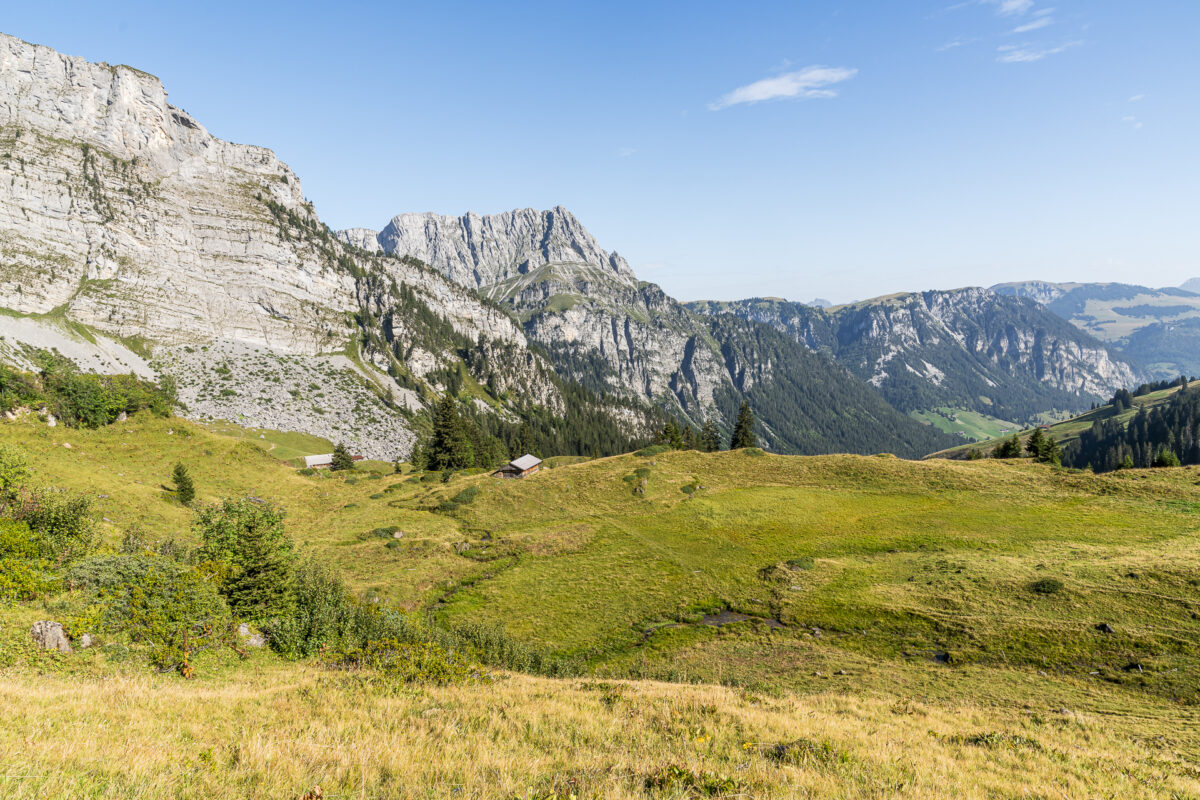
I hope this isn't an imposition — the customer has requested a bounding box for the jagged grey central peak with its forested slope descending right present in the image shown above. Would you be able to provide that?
[338,207,947,456]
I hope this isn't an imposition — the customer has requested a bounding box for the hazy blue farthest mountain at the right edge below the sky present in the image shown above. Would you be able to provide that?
[992,281,1200,378]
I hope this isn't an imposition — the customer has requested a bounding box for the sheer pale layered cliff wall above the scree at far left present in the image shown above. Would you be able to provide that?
[0,36,354,353]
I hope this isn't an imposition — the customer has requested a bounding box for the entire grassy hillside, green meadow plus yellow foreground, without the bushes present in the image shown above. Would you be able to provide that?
[0,417,1200,798]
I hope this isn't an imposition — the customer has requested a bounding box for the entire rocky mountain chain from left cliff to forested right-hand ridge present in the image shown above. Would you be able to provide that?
[0,36,1171,458]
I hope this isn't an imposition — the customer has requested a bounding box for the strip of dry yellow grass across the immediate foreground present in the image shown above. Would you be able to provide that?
[0,656,1200,800]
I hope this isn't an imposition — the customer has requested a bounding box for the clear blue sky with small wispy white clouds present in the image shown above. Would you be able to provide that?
[0,0,1200,301]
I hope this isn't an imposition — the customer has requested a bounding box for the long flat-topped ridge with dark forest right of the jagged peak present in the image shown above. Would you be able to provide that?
[690,289,1140,421]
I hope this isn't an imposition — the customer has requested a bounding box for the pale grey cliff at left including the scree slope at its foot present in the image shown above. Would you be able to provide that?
[0,35,576,459]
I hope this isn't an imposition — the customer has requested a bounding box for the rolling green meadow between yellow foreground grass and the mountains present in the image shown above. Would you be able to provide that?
[7,417,1200,747]
